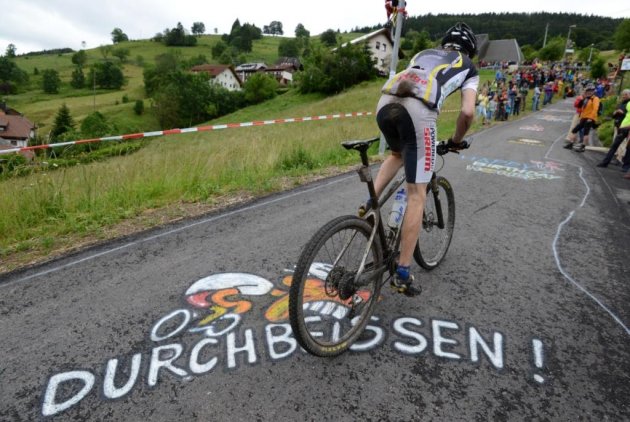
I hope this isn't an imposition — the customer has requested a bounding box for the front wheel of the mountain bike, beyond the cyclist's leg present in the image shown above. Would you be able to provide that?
[413,176,455,270]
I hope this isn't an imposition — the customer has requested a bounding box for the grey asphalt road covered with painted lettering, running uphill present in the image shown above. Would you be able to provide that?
[0,101,630,421]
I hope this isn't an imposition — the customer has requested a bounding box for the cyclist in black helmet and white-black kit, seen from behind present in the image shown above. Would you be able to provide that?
[375,22,479,296]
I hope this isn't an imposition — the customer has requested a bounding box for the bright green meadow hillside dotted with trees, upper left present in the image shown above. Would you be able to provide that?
[4,33,368,135]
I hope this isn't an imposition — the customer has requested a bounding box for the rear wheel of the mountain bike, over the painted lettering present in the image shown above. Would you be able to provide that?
[289,216,383,356]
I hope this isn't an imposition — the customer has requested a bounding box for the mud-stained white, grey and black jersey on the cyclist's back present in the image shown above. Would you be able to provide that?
[381,49,479,112]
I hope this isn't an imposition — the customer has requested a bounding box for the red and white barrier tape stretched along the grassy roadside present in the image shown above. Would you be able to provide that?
[0,112,373,154]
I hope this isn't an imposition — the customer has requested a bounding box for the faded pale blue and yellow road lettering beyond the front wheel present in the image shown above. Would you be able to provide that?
[460,155,564,180]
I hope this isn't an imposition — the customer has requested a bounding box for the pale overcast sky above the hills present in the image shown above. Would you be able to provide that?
[0,0,630,55]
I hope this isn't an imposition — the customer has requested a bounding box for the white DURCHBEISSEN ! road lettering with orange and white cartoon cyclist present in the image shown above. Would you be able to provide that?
[41,264,548,416]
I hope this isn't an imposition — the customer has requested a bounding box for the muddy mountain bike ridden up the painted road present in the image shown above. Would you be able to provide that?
[289,138,470,356]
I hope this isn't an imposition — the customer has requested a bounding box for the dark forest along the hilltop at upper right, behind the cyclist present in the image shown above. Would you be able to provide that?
[405,12,623,50]
